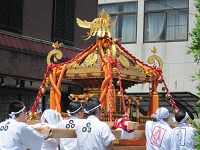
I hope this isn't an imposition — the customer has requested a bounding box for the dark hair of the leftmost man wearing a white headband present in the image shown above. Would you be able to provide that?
[7,100,24,118]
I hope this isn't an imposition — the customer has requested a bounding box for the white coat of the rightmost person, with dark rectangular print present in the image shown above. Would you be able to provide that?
[173,123,195,150]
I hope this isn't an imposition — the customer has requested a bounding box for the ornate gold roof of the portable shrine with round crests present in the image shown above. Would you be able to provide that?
[61,40,155,89]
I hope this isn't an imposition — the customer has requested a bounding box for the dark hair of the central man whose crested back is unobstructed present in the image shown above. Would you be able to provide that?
[84,97,100,115]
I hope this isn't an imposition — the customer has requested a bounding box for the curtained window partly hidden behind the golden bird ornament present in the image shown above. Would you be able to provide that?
[98,2,137,42]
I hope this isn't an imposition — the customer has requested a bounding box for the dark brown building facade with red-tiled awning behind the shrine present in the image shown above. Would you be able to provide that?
[0,0,98,121]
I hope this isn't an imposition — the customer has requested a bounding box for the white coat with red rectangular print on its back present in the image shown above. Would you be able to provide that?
[145,120,180,150]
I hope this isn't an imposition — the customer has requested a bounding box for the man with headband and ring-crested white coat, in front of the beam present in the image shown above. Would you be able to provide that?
[76,97,116,150]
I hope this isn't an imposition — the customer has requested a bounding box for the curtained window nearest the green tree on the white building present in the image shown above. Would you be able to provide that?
[144,0,188,42]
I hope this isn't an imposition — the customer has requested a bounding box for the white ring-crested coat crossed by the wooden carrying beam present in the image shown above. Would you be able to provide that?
[56,116,81,150]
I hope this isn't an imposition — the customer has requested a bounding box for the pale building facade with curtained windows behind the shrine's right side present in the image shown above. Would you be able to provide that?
[98,0,200,117]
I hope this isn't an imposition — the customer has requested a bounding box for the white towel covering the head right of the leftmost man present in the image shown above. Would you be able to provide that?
[40,109,63,125]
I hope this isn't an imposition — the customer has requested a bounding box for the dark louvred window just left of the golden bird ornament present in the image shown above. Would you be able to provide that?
[52,0,75,45]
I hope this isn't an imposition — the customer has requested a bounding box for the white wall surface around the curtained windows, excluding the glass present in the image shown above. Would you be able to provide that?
[98,0,200,94]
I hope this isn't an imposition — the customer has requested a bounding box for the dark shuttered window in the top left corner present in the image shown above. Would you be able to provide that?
[0,0,23,33]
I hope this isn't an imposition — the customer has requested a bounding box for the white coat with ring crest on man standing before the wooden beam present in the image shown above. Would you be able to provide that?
[76,115,115,150]
